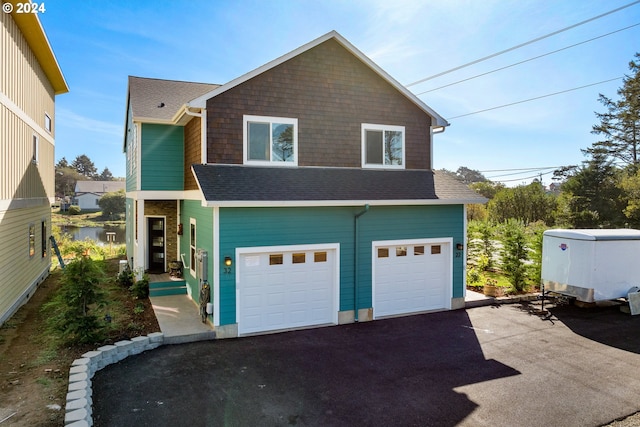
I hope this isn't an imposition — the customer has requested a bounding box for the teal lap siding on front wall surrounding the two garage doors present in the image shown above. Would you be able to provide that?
[219,205,464,324]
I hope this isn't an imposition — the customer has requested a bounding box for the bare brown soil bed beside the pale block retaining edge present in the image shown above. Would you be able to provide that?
[0,259,160,427]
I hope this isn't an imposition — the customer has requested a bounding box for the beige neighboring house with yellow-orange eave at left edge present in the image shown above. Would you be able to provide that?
[0,0,69,325]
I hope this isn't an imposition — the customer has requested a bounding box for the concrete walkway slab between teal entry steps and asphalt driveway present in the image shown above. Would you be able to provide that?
[149,295,216,344]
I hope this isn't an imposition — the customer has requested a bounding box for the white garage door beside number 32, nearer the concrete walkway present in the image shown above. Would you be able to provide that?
[236,245,338,334]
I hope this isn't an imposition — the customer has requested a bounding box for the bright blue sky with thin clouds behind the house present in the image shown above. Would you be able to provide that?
[40,0,640,185]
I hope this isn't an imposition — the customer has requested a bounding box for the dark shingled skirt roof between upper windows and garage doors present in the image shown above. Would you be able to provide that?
[192,164,487,207]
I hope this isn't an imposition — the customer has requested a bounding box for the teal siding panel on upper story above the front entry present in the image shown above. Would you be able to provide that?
[140,124,184,191]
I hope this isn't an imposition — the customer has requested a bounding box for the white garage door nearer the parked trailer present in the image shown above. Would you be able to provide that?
[373,241,452,317]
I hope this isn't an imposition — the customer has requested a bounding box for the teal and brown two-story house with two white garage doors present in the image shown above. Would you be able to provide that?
[124,32,486,338]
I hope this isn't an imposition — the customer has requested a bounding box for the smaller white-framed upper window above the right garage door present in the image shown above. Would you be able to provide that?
[362,123,404,169]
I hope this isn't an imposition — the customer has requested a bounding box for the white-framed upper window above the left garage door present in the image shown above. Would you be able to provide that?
[243,116,298,166]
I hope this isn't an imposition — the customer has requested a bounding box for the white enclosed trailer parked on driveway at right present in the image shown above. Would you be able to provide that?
[542,229,640,302]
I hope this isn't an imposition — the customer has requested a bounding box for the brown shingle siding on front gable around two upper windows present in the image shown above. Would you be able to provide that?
[207,40,431,169]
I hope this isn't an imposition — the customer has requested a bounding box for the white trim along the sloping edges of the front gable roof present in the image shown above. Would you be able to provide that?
[187,31,449,126]
